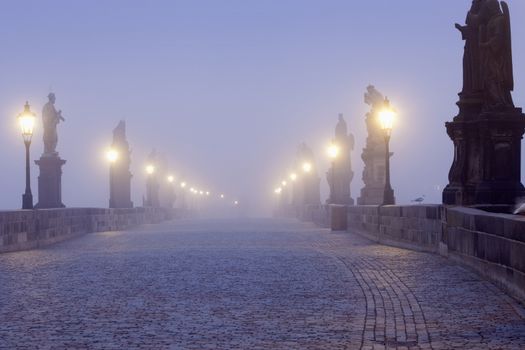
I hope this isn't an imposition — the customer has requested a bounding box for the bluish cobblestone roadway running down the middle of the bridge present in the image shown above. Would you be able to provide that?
[0,219,525,349]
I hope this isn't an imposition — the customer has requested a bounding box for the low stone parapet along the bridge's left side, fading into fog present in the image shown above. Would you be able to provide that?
[0,208,174,253]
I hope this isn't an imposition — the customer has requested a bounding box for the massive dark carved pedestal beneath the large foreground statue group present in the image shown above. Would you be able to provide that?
[443,108,525,205]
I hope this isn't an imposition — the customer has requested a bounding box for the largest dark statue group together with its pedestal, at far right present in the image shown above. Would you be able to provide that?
[443,0,525,205]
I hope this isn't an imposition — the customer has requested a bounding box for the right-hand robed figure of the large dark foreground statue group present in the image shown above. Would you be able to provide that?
[480,0,514,110]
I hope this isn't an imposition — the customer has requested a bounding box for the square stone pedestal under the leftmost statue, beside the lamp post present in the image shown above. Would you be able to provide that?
[35,155,66,209]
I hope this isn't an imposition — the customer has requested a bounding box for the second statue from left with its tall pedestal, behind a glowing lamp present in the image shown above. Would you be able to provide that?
[109,121,133,208]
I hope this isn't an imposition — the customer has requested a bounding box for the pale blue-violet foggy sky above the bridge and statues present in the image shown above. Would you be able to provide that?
[0,0,525,215]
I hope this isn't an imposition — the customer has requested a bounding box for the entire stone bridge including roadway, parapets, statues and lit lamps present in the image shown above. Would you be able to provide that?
[0,0,525,349]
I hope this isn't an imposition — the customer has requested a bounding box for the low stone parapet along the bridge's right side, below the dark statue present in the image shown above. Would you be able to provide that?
[347,205,525,301]
